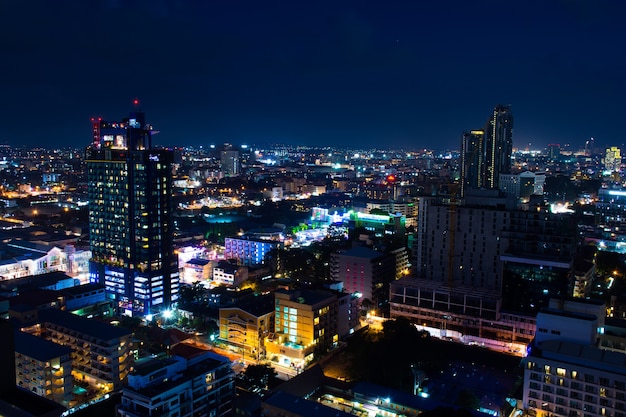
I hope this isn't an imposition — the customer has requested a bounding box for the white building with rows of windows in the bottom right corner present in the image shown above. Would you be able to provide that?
[523,300,626,417]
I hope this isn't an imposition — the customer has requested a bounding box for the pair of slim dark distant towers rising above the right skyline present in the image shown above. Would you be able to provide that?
[460,104,513,196]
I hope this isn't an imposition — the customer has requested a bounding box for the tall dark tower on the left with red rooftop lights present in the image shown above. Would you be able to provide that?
[86,112,178,316]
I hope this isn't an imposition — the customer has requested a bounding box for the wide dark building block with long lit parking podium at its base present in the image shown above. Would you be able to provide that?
[390,190,576,356]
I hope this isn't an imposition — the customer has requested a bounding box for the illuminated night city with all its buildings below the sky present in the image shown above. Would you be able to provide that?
[0,100,626,417]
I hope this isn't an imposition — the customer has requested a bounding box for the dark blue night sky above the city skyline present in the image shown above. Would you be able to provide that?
[0,0,626,150]
